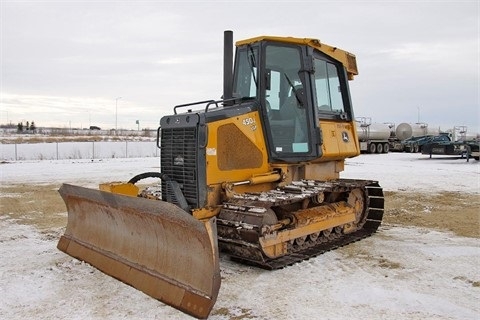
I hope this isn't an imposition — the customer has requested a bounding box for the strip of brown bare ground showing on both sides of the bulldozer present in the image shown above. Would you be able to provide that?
[0,185,480,238]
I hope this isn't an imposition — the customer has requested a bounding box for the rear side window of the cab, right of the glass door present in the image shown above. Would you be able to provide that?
[315,59,345,113]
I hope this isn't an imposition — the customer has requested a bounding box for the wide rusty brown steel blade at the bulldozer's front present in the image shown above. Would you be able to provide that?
[57,184,220,318]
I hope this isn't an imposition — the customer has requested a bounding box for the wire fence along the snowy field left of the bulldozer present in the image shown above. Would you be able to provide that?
[0,141,159,161]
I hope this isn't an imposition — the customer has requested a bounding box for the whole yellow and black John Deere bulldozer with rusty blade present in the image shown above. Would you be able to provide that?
[57,31,384,318]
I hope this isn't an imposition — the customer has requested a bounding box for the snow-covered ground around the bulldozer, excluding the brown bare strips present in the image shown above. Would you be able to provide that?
[0,153,480,320]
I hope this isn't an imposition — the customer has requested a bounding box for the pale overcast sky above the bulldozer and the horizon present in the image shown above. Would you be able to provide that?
[0,0,480,132]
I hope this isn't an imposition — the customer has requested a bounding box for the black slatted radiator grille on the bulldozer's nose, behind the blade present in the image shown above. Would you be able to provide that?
[160,127,199,208]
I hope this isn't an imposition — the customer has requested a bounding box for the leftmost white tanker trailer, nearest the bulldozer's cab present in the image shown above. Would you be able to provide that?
[356,117,394,153]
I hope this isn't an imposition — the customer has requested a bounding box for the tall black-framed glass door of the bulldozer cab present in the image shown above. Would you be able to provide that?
[260,42,320,163]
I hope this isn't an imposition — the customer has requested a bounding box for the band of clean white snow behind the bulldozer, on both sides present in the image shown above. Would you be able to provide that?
[0,153,480,193]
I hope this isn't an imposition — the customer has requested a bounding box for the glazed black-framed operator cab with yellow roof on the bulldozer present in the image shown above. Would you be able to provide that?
[233,37,353,162]
